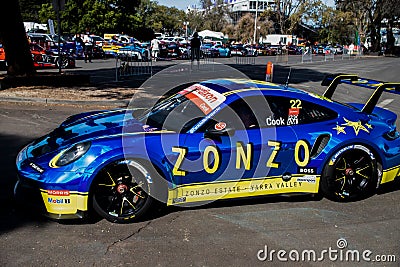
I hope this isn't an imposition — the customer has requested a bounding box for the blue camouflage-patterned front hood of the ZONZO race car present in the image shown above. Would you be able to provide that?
[28,109,148,157]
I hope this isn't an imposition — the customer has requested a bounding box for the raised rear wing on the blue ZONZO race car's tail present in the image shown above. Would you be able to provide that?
[321,74,400,114]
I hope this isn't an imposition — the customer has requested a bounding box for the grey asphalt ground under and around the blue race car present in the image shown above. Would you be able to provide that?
[0,57,400,266]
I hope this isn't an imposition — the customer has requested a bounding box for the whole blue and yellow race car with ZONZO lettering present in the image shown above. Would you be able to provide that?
[15,75,400,223]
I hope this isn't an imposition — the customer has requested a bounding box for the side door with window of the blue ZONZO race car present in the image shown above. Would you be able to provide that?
[174,95,297,187]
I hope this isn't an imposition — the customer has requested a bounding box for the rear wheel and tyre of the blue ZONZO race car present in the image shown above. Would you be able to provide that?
[321,145,382,202]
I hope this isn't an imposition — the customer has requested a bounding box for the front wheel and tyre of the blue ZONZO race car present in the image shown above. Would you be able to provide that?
[92,160,155,223]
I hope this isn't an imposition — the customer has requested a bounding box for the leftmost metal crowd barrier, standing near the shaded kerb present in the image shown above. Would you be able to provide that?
[115,53,153,81]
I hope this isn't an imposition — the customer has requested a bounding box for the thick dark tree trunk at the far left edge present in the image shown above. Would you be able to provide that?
[0,0,35,75]
